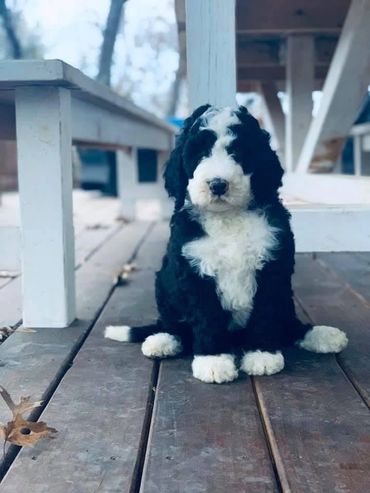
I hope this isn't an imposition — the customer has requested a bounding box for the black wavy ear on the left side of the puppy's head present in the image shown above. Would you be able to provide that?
[163,104,210,210]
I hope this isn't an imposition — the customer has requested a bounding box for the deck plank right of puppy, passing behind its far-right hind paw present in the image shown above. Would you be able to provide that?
[294,255,370,406]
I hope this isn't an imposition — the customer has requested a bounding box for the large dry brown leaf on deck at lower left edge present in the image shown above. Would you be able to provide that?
[0,386,57,447]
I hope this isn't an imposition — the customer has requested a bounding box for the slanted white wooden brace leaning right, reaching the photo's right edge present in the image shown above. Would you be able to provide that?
[297,0,370,173]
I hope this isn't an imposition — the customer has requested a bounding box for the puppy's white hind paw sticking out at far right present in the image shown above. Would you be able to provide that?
[298,325,348,353]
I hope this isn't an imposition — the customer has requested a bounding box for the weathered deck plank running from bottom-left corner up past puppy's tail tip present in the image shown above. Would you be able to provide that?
[1,225,167,493]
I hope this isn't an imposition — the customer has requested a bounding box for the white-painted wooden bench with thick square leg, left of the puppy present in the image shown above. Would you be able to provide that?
[0,60,174,327]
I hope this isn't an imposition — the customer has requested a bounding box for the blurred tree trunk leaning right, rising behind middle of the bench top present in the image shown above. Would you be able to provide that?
[97,0,127,86]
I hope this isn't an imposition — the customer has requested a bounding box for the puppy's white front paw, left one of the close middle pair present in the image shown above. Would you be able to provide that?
[191,354,238,383]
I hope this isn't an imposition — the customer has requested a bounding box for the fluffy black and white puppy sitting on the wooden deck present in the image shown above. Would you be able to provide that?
[106,105,348,383]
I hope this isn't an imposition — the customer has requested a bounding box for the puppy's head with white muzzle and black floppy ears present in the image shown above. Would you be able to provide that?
[165,106,282,212]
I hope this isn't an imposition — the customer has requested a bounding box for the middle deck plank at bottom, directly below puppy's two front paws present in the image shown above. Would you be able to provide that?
[140,359,278,493]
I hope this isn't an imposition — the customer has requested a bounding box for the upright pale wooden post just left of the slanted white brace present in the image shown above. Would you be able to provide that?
[285,35,315,171]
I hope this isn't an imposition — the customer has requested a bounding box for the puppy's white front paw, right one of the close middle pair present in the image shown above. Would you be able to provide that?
[240,350,284,375]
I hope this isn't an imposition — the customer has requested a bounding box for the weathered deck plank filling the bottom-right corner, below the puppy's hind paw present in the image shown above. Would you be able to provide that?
[255,350,370,493]
